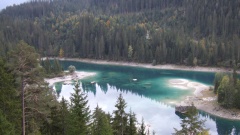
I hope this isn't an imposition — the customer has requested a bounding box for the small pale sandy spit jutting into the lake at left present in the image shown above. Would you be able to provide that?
[44,71,96,86]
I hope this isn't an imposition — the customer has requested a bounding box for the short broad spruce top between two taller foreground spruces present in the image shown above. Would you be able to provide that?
[92,106,113,135]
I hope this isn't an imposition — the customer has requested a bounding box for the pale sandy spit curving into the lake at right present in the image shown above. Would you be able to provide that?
[169,79,240,120]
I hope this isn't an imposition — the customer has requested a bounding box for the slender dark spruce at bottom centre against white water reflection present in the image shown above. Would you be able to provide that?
[112,94,128,135]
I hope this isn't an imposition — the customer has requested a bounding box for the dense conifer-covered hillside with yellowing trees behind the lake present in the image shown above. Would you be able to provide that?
[0,0,240,66]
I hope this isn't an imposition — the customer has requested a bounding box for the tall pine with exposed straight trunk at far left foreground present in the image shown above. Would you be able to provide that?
[9,41,56,135]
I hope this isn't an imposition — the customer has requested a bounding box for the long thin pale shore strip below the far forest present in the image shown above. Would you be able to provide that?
[49,58,232,72]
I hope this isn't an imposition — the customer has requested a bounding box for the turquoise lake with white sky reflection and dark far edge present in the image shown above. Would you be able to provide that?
[55,61,240,135]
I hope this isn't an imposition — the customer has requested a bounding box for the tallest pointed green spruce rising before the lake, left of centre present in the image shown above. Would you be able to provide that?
[69,83,90,135]
